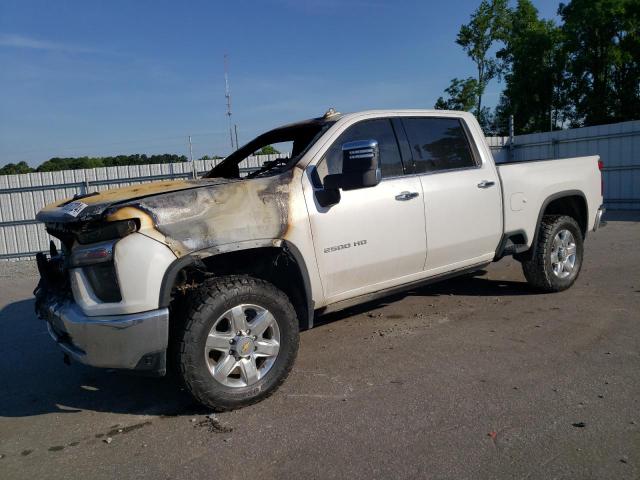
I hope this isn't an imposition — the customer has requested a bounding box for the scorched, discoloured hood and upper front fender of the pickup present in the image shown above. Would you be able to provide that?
[36,171,293,257]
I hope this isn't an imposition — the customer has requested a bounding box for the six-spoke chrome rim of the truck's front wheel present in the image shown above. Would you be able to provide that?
[204,304,280,388]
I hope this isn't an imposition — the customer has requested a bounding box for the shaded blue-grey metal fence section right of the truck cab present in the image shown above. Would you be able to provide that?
[487,120,640,210]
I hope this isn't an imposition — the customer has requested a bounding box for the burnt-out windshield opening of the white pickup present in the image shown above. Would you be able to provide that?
[205,120,333,178]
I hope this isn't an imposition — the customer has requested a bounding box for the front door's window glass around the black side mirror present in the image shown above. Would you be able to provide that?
[317,118,404,181]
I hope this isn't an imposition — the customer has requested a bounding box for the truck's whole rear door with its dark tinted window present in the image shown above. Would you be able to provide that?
[402,117,502,274]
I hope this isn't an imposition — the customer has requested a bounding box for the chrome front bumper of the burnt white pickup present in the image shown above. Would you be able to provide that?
[38,297,169,375]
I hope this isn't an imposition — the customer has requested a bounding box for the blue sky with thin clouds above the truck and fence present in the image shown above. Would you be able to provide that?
[0,0,558,166]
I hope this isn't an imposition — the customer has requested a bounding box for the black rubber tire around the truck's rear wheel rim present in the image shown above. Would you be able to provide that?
[522,215,584,292]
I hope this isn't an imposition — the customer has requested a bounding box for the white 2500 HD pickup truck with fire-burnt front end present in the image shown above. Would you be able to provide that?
[35,110,603,409]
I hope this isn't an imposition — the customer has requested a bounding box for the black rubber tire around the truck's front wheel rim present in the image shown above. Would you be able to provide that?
[175,275,299,411]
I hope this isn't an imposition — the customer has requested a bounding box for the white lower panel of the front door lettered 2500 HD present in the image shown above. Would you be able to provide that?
[306,172,427,299]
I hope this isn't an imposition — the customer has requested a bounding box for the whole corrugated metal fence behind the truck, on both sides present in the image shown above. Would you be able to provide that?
[0,121,640,260]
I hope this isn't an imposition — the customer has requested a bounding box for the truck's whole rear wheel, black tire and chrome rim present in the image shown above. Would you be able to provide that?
[522,215,584,292]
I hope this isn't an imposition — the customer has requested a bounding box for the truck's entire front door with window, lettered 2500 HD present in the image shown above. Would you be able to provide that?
[305,118,426,303]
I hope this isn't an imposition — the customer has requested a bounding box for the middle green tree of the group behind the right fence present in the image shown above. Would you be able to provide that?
[495,0,566,134]
